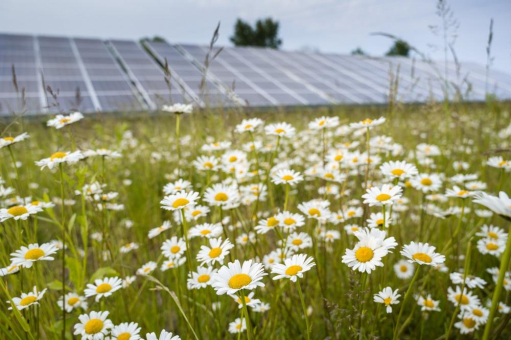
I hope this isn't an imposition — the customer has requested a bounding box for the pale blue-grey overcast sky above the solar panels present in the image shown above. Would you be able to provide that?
[0,0,511,72]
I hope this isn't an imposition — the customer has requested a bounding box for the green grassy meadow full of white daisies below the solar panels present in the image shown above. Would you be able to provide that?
[0,100,511,340]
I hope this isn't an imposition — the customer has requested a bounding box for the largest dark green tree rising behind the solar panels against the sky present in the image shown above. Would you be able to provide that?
[231,18,282,49]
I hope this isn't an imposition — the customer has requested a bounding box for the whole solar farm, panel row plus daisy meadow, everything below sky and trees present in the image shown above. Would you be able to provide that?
[0,23,511,340]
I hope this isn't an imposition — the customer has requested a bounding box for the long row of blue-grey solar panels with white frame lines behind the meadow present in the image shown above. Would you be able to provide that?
[0,34,511,115]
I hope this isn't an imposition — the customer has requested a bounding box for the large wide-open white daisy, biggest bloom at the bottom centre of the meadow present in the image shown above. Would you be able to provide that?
[212,260,267,295]
